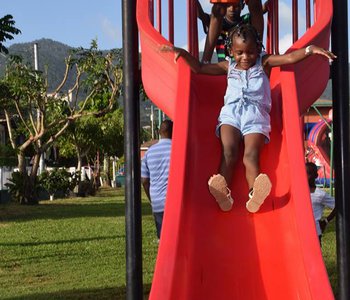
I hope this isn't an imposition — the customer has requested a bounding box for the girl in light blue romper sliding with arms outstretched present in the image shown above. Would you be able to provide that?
[160,24,336,213]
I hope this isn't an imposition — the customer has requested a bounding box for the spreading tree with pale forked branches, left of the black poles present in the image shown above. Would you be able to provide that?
[0,41,122,203]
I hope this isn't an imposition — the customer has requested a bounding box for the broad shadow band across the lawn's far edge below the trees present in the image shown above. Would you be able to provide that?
[0,201,152,222]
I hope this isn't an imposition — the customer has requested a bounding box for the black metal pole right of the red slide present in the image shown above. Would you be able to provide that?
[332,0,350,300]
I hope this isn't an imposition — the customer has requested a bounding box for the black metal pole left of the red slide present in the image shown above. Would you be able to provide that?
[122,0,143,300]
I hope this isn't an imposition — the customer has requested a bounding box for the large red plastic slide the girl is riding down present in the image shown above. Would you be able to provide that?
[137,0,334,300]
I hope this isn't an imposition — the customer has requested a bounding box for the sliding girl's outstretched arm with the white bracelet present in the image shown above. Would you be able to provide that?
[263,45,336,69]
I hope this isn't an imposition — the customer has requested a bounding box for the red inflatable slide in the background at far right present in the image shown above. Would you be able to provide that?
[307,120,331,184]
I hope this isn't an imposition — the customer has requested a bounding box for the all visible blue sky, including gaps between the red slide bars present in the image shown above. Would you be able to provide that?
[0,0,350,53]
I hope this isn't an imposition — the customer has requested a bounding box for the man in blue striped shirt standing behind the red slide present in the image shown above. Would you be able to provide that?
[141,120,173,239]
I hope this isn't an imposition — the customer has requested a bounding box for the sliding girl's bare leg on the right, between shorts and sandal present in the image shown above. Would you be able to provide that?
[243,133,265,190]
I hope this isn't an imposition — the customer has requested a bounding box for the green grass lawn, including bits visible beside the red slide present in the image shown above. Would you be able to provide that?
[0,189,337,300]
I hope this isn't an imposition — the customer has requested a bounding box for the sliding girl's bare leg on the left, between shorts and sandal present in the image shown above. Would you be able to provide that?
[219,124,241,185]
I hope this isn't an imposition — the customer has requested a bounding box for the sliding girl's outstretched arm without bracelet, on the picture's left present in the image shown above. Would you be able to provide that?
[160,45,228,75]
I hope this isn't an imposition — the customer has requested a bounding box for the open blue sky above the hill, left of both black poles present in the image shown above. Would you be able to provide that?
[0,0,122,50]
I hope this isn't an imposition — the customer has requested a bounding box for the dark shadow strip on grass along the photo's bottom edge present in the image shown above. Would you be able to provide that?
[2,284,151,300]
